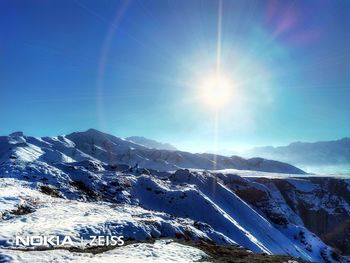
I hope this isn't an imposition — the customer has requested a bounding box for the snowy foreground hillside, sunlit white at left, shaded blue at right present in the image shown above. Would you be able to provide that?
[0,170,344,262]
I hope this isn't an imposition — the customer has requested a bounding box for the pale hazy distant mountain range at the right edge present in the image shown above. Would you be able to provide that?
[244,138,350,165]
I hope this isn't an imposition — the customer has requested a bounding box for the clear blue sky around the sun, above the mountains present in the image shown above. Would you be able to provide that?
[0,0,350,151]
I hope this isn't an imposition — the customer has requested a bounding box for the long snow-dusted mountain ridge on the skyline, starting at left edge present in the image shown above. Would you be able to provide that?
[0,129,305,174]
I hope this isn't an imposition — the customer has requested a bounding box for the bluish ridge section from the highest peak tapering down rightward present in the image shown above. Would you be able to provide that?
[59,129,304,174]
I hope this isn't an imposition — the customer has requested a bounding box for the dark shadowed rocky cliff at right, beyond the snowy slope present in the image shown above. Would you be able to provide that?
[229,177,350,255]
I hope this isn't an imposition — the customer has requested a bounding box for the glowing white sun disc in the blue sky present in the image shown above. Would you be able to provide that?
[198,72,233,109]
